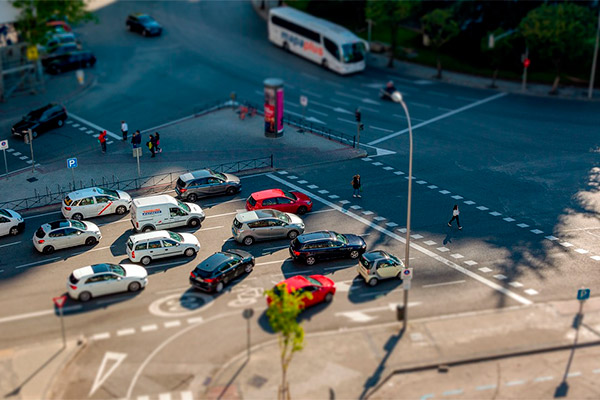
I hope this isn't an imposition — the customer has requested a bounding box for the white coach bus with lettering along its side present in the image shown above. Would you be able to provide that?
[269,7,368,74]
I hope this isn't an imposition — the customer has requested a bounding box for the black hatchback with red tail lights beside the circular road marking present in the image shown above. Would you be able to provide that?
[190,249,254,293]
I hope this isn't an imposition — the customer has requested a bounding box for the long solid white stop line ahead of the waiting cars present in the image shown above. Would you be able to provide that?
[267,174,533,305]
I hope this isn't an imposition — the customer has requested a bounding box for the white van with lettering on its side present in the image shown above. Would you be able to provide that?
[131,194,205,232]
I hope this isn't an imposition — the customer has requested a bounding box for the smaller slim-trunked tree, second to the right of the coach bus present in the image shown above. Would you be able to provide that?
[421,8,460,79]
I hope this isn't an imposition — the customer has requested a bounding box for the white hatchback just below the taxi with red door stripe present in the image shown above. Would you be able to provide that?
[32,219,102,254]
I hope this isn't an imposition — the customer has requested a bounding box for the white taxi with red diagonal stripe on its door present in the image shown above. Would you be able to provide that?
[60,187,131,220]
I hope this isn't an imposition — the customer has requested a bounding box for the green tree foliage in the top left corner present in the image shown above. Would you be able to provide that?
[12,0,95,44]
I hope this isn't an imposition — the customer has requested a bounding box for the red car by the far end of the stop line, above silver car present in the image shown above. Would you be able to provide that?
[246,189,312,215]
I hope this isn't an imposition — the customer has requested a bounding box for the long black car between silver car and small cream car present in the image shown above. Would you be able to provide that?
[290,231,367,265]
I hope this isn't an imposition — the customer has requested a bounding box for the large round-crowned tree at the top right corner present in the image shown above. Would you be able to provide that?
[519,3,595,94]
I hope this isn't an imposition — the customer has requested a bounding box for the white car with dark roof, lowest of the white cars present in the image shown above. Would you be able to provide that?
[67,263,148,301]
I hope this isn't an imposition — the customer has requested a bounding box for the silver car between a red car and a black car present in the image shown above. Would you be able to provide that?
[231,209,304,246]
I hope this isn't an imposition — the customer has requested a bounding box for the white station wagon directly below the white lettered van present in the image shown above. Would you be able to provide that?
[126,231,200,265]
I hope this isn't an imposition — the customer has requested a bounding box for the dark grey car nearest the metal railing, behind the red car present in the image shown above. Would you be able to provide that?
[175,169,242,202]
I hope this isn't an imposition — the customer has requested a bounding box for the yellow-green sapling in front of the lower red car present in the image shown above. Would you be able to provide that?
[265,283,312,400]
